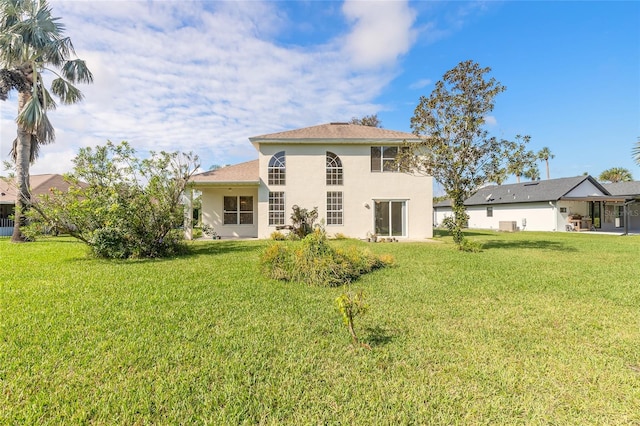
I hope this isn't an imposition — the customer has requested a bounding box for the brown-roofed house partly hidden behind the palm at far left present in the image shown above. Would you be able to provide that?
[0,174,69,237]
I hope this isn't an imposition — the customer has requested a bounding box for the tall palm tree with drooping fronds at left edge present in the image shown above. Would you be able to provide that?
[0,0,93,242]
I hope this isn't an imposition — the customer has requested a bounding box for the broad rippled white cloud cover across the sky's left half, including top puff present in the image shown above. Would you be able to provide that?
[0,0,414,173]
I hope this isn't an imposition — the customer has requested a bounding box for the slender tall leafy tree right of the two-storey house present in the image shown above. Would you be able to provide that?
[399,61,529,248]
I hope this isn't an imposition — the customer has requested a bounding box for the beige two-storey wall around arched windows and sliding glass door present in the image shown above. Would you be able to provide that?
[258,144,433,239]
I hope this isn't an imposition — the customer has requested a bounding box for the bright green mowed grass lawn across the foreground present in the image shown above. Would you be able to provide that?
[0,232,640,425]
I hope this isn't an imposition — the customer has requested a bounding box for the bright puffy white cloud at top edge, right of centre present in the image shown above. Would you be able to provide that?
[342,0,416,68]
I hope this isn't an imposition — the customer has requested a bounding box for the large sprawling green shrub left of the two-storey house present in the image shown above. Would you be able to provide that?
[25,142,197,258]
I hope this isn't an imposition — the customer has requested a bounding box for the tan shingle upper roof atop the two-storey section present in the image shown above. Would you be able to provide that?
[249,123,419,144]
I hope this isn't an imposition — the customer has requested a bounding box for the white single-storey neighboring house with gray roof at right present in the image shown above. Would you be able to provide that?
[434,176,640,232]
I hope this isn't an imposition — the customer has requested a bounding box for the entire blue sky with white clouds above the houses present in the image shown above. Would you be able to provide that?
[0,0,640,179]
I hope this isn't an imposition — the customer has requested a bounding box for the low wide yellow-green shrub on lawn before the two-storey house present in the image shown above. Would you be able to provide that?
[260,228,393,287]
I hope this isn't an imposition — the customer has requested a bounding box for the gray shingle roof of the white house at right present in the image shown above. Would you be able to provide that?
[464,176,606,206]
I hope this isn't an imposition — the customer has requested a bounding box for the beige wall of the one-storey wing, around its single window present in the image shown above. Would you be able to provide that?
[198,186,258,238]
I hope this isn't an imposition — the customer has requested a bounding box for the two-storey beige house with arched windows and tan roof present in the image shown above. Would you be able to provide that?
[191,123,433,239]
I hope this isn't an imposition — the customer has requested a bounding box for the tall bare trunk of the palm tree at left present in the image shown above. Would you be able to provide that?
[11,92,32,243]
